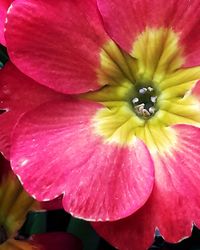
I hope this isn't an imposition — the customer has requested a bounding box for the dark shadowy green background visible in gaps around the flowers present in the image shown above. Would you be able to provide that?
[0,45,200,250]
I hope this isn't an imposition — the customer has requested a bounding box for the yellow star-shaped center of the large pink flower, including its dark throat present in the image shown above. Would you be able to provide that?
[82,28,200,153]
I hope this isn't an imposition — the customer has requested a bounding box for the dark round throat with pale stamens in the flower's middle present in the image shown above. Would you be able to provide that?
[132,85,157,119]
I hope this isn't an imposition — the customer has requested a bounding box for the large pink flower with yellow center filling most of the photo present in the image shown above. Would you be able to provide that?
[0,0,200,250]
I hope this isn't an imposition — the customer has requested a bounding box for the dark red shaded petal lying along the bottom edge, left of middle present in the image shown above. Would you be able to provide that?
[30,232,83,250]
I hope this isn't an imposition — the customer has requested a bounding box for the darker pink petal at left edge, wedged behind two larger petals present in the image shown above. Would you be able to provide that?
[0,62,64,158]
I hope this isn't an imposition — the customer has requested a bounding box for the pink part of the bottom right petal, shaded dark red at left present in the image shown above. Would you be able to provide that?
[93,125,200,250]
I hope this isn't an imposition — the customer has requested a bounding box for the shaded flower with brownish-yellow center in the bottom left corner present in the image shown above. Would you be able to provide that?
[0,155,82,250]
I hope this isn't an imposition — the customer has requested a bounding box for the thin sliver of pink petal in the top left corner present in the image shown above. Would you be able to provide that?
[0,0,13,46]
